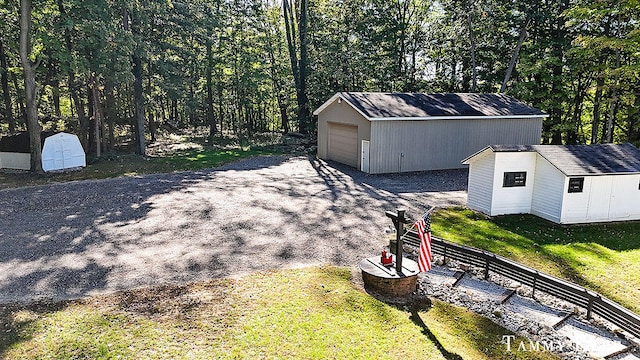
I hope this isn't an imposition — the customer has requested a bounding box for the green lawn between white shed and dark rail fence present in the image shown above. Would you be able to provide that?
[432,208,640,313]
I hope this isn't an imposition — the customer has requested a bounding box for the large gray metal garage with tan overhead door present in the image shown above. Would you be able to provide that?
[313,92,548,174]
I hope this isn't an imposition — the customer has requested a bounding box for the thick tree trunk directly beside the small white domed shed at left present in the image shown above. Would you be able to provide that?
[20,0,43,173]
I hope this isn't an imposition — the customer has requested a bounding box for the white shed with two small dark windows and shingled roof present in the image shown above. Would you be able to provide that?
[463,144,640,224]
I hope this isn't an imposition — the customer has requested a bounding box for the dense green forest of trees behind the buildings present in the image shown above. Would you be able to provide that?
[0,0,640,171]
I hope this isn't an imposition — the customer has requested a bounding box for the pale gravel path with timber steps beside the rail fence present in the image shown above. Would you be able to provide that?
[418,257,640,360]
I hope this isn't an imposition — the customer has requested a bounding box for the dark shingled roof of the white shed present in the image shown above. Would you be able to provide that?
[465,143,640,176]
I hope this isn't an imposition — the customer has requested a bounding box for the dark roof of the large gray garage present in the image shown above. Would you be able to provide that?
[340,92,546,119]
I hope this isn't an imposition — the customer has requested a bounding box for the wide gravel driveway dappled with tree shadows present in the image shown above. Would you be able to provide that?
[0,156,467,302]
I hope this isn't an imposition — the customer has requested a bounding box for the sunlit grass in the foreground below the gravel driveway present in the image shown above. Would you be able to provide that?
[0,267,555,360]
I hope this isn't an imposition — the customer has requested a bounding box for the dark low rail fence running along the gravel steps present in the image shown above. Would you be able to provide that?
[404,229,640,338]
